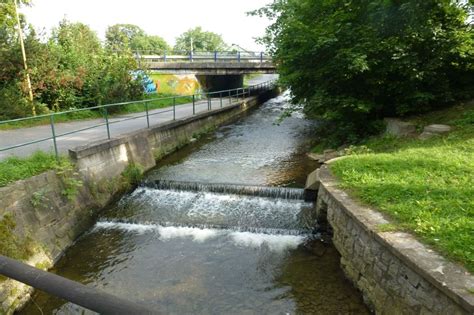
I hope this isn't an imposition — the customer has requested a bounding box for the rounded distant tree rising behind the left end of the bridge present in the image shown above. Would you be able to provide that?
[105,24,169,52]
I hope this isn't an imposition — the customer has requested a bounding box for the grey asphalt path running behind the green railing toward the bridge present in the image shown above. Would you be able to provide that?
[0,75,275,160]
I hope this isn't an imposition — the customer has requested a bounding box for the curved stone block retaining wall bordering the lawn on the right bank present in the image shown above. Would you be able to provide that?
[316,165,474,315]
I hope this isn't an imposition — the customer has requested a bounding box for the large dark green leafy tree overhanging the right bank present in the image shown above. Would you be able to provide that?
[254,0,474,146]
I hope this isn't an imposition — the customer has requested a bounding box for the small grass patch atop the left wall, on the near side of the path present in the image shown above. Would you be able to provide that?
[0,151,63,187]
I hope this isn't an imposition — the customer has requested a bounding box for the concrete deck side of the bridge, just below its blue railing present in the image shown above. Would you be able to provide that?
[146,62,276,75]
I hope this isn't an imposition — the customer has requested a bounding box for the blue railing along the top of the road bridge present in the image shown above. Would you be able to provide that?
[134,51,272,63]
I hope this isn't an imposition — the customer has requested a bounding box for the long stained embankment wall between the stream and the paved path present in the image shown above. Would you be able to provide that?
[0,89,279,314]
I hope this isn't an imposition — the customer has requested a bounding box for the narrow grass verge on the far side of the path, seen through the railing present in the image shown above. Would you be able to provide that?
[0,94,192,130]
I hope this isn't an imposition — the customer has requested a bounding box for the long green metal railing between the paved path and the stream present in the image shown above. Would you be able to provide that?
[0,80,276,159]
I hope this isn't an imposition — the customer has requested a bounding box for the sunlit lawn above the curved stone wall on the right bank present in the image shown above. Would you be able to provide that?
[331,106,474,272]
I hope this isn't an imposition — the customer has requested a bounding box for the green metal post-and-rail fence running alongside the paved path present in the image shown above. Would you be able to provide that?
[0,81,275,159]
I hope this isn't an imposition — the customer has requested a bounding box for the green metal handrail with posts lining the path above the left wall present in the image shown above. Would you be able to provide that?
[0,80,275,159]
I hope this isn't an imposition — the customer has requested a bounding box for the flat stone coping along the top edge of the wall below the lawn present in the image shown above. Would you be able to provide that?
[319,165,474,314]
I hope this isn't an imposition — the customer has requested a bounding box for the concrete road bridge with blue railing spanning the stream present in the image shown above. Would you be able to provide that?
[135,51,276,92]
